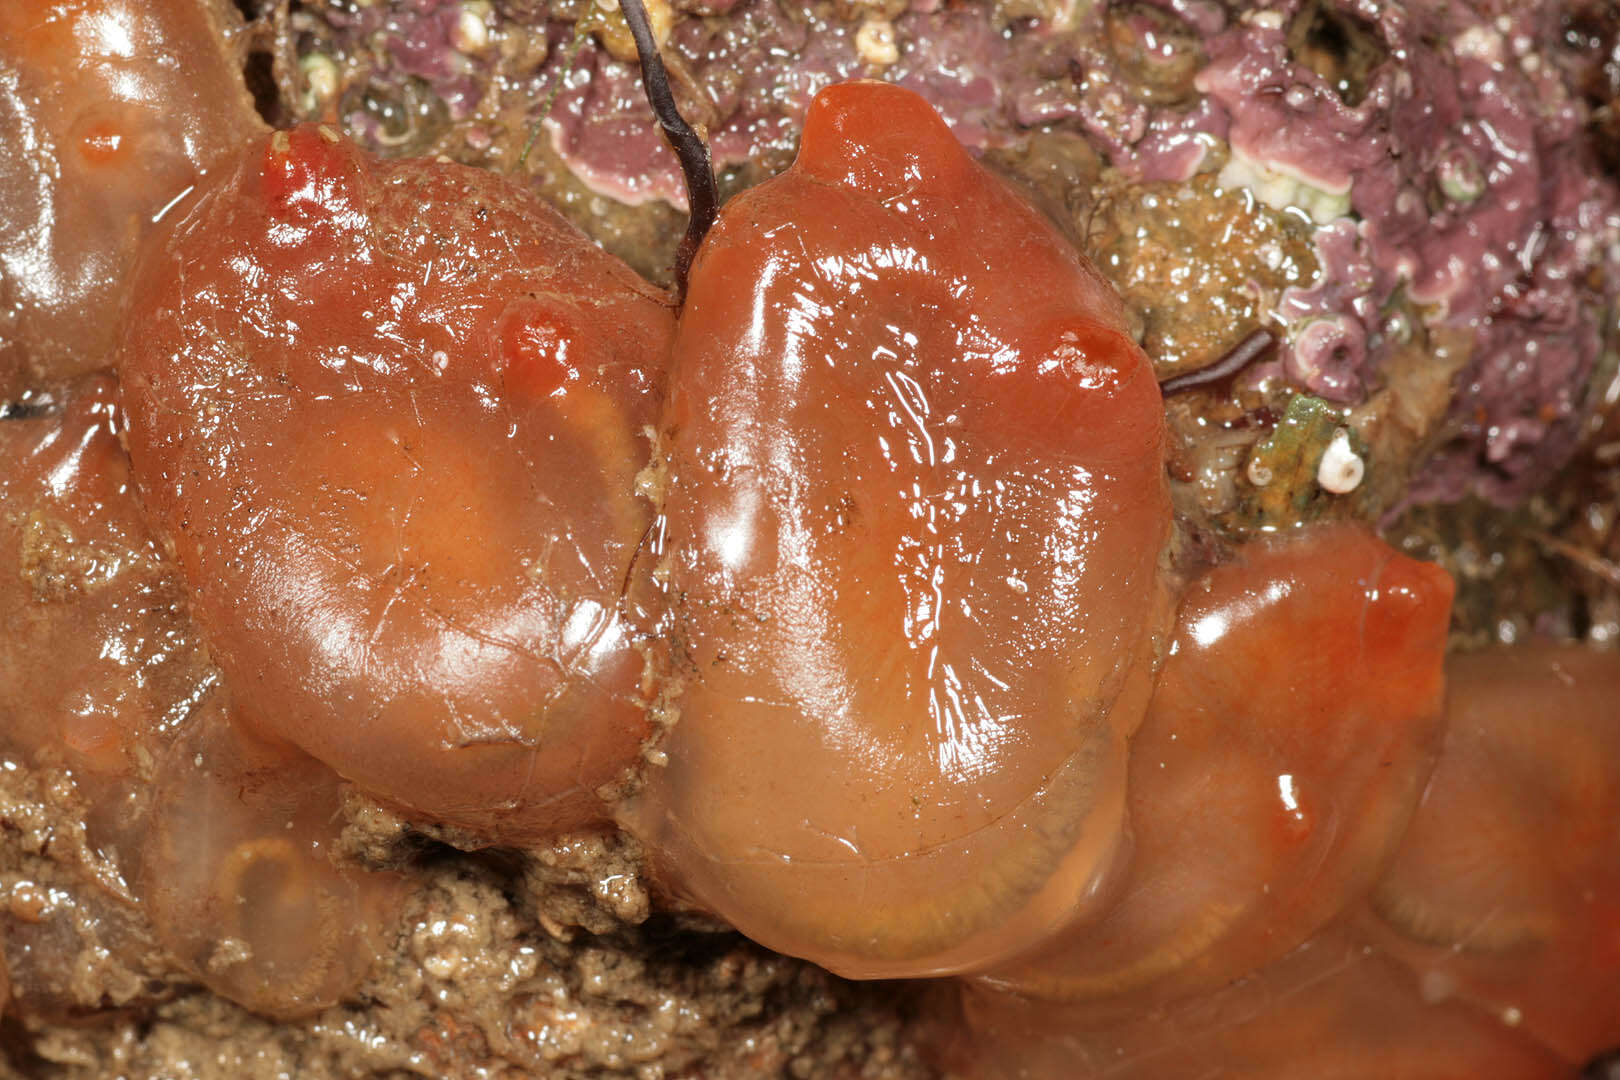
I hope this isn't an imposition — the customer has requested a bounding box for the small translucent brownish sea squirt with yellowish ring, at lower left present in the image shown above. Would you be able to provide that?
[136,719,405,1017]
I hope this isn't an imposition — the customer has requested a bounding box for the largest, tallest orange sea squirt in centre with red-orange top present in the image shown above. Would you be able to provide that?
[629,83,1170,978]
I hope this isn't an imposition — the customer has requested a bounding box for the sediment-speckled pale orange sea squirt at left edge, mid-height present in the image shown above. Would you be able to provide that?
[0,377,208,790]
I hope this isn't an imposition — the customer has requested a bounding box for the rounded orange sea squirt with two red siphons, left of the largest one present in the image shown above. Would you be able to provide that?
[120,126,672,839]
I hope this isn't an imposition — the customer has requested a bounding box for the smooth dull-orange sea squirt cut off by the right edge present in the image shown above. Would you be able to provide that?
[1362,644,1620,1062]
